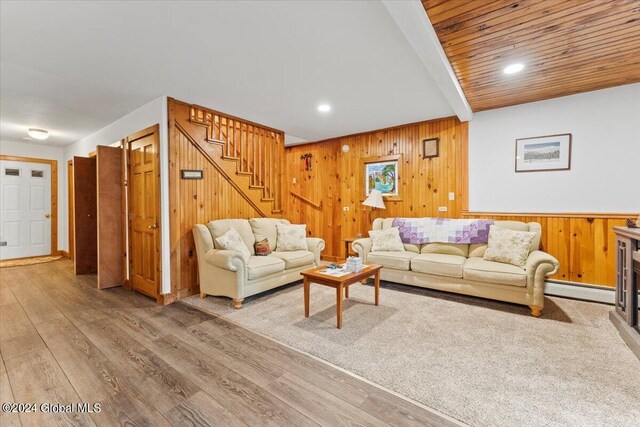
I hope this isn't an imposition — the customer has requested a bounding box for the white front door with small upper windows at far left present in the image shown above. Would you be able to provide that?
[0,160,51,260]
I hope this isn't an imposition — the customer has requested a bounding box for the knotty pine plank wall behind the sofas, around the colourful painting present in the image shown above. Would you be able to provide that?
[284,118,468,260]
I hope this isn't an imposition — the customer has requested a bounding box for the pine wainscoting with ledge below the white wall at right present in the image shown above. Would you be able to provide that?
[462,212,637,287]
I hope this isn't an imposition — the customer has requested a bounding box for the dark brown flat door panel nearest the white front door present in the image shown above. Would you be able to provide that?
[73,157,98,274]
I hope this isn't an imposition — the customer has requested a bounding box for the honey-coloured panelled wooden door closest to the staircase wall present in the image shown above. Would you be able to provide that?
[127,125,161,298]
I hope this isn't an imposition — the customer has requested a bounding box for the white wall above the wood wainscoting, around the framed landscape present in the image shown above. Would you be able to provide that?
[469,84,640,213]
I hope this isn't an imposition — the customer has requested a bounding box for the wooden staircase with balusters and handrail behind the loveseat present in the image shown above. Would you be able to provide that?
[189,105,284,216]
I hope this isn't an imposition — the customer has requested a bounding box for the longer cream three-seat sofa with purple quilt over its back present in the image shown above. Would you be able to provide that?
[352,218,560,317]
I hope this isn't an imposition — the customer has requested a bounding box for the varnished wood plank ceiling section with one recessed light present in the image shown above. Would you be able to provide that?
[422,0,640,111]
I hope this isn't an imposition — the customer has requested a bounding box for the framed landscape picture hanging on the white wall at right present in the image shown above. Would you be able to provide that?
[516,133,571,172]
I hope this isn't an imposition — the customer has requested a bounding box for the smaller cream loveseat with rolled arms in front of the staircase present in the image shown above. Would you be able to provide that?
[193,218,324,308]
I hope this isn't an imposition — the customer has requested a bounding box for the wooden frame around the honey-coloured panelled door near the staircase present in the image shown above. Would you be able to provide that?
[123,124,163,303]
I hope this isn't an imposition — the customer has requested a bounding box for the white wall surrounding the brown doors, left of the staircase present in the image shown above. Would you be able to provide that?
[63,96,171,293]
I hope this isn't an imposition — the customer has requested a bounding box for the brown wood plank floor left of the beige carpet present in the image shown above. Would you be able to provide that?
[0,261,460,426]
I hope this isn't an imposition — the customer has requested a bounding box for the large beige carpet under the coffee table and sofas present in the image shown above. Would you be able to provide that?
[182,282,640,427]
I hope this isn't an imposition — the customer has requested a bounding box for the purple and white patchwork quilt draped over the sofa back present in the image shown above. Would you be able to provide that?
[392,218,493,245]
